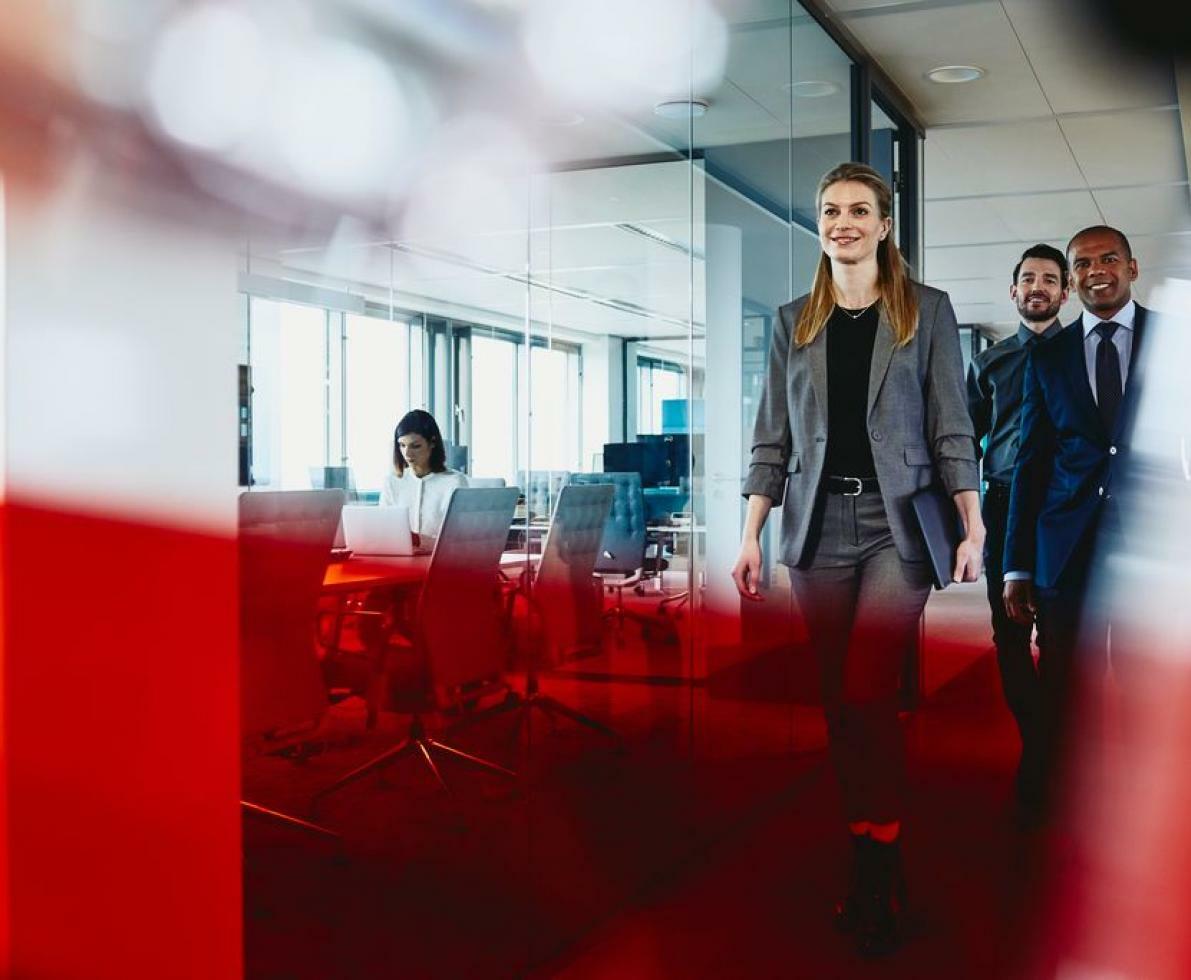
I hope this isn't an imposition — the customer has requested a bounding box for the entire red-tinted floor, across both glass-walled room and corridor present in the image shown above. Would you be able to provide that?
[245,587,1071,980]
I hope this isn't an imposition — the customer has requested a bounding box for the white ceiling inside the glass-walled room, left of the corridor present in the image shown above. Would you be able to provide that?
[254,0,849,352]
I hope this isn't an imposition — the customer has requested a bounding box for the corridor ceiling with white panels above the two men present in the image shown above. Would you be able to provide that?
[828,0,1191,332]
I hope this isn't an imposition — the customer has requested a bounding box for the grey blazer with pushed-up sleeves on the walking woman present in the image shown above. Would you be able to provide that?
[744,283,979,566]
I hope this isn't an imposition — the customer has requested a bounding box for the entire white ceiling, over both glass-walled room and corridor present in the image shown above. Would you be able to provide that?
[257,0,1191,349]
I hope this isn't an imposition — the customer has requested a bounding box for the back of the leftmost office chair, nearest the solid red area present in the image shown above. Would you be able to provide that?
[238,489,344,737]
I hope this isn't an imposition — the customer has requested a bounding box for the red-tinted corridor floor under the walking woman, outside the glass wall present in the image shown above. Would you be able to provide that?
[530,655,1045,980]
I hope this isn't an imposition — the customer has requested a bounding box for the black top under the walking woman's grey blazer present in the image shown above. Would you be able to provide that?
[823,302,880,477]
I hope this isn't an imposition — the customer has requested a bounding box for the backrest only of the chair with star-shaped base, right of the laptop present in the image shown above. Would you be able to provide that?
[418,487,519,703]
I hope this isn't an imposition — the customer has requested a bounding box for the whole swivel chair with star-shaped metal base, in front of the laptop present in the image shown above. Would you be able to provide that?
[313,487,518,807]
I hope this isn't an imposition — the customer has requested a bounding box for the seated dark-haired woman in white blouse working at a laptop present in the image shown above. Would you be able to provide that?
[380,408,467,549]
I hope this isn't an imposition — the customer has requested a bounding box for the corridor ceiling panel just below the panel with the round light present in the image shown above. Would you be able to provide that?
[924,119,1084,199]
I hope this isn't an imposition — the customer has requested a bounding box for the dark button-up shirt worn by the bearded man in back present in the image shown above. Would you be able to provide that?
[968,320,1062,486]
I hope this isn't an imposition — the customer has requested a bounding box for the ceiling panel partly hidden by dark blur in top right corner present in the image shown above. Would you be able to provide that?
[1004,0,1174,113]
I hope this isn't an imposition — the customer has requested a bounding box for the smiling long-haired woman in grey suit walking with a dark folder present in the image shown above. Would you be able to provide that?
[732,163,984,954]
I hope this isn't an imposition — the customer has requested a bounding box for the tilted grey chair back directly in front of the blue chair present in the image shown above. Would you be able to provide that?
[534,483,615,658]
